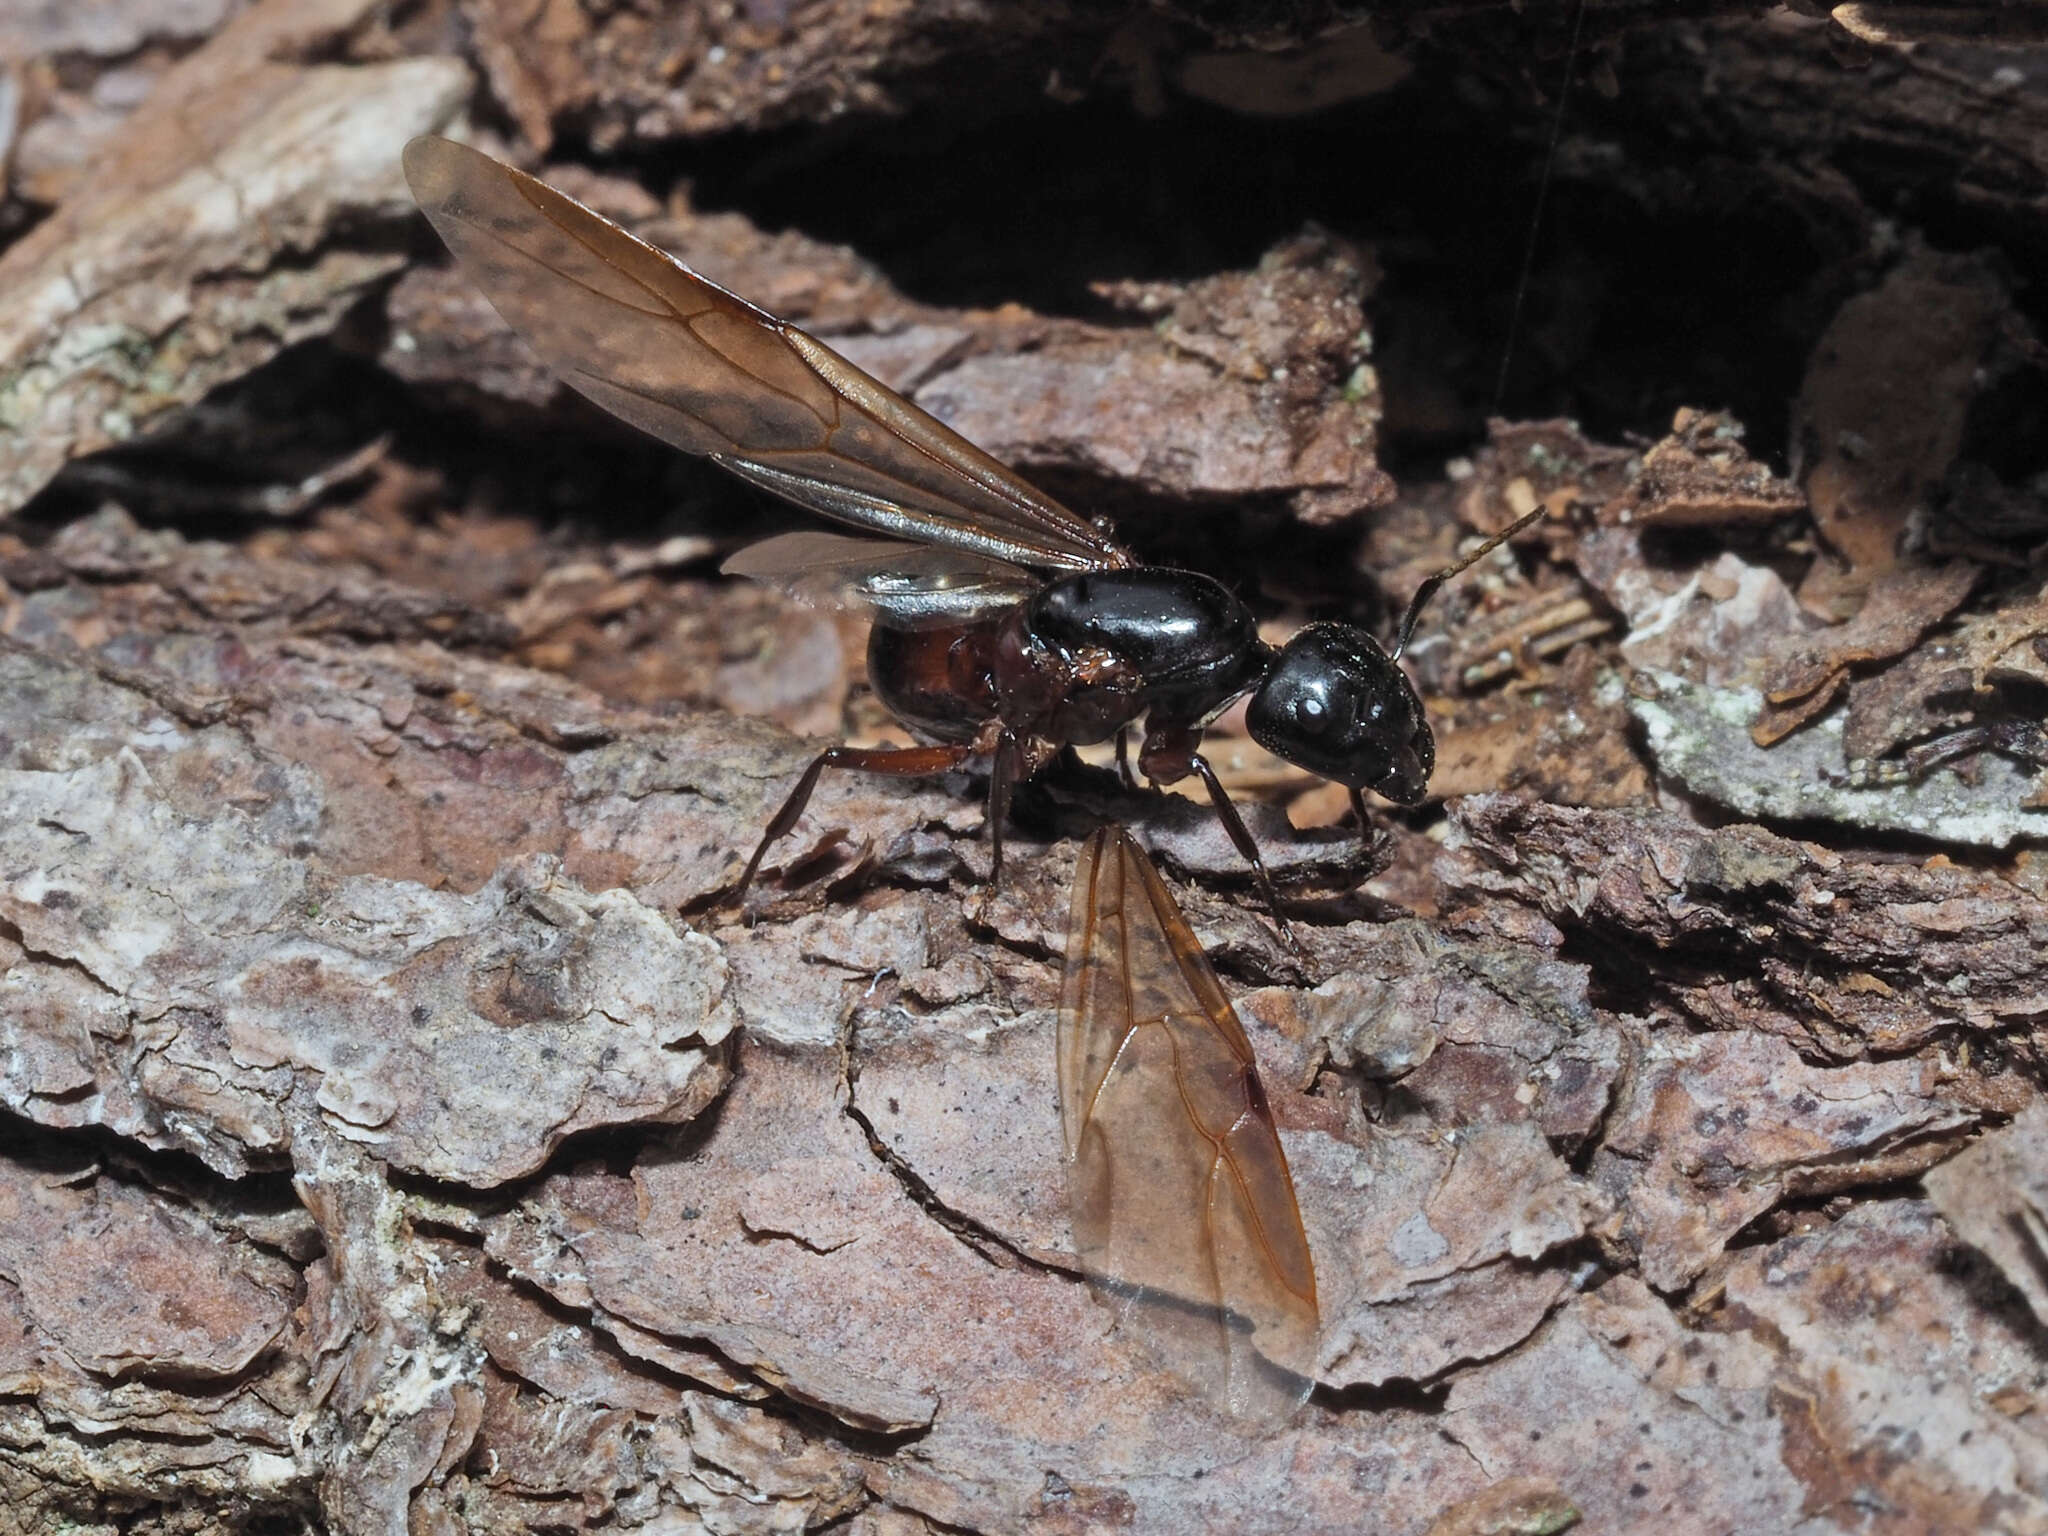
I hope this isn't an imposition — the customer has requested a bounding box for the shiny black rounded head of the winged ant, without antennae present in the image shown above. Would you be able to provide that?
[1245,625,1436,805]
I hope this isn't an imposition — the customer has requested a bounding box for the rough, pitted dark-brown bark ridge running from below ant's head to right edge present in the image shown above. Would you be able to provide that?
[1444,797,2048,1059]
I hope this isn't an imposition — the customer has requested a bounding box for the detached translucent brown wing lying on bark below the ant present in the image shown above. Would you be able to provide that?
[1059,827,1319,1423]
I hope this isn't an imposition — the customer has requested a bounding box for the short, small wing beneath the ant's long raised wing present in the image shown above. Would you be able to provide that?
[723,532,1044,629]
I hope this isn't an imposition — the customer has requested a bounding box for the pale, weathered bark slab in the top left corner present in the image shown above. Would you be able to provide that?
[0,0,469,514]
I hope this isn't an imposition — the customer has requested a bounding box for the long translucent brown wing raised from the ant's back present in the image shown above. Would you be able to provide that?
[406,137,1130,571]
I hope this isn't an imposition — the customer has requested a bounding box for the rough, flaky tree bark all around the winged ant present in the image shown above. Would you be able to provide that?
[0,0,2048,1536]
